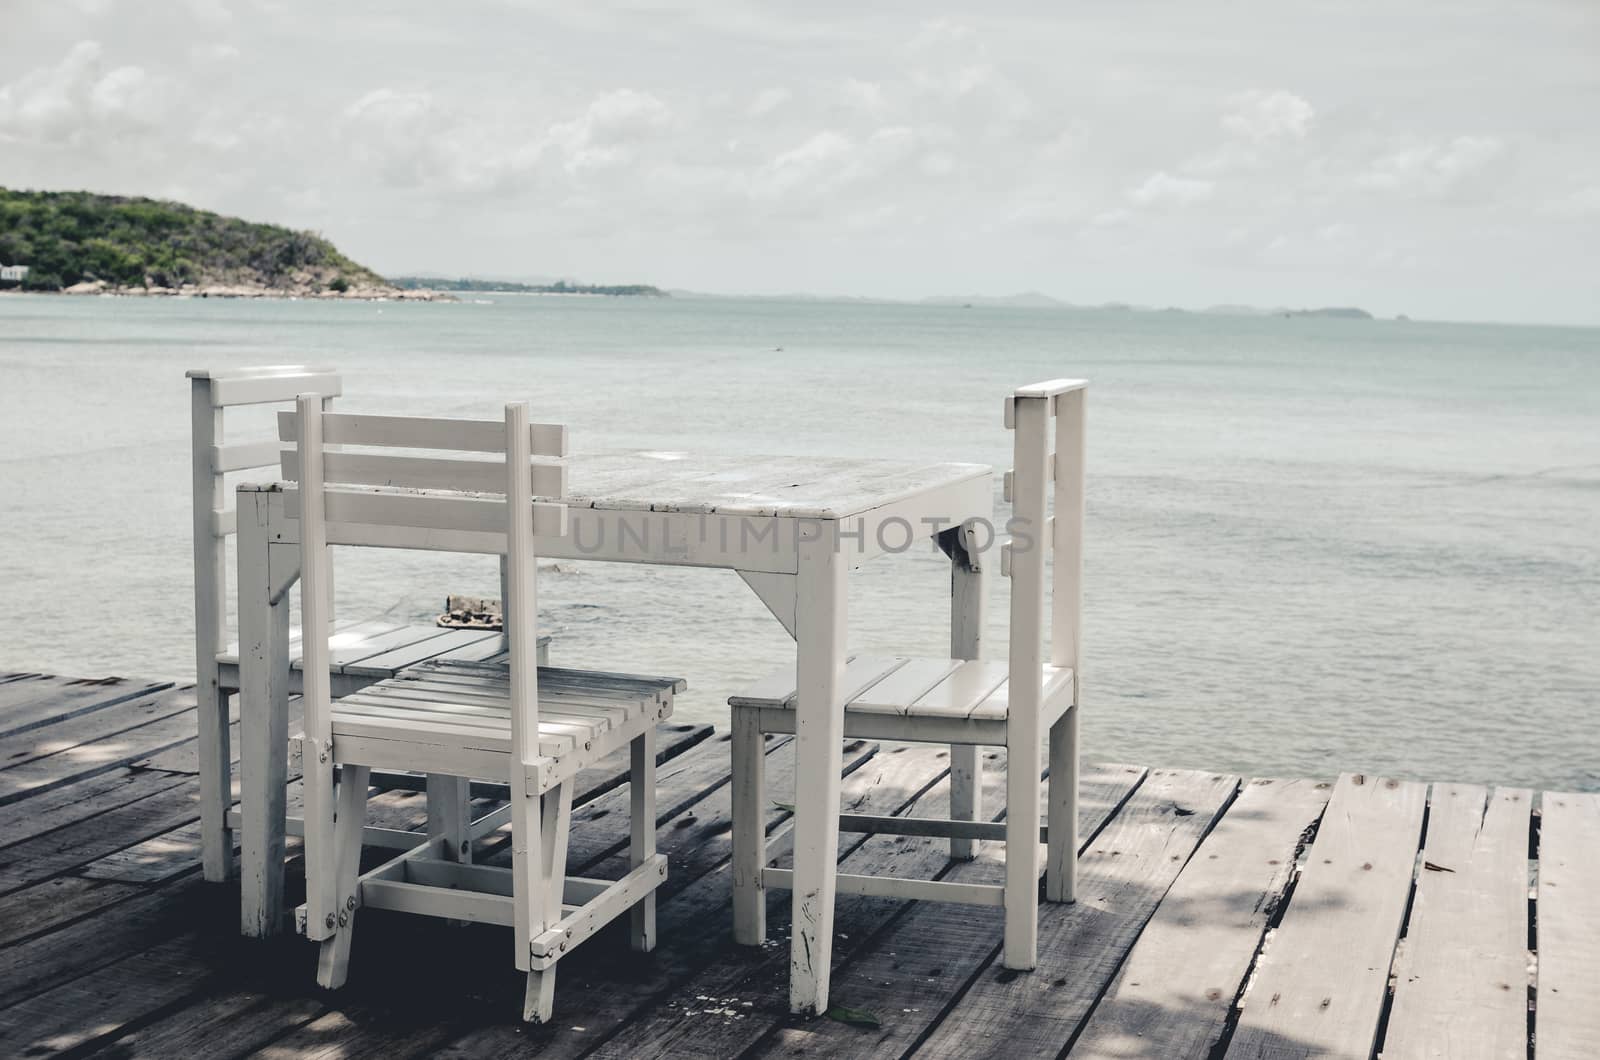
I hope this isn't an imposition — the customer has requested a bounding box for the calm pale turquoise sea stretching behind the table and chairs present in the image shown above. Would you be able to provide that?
[0,296,1600,789]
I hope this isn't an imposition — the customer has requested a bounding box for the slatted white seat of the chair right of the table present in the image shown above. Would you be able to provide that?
[728,656,1072,738]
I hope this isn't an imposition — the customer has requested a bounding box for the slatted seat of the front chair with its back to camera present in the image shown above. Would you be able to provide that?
[315,660,686,780]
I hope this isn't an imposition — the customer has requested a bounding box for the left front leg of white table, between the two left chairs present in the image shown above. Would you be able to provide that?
[238,493,290,938]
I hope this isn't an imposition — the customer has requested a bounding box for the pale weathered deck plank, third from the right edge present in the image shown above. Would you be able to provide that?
[1227,773,1427,1060]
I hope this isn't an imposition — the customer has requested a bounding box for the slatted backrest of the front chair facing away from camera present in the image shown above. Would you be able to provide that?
[278,403,566,762]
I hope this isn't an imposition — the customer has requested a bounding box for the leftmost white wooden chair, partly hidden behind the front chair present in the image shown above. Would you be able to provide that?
[187,365,549,881]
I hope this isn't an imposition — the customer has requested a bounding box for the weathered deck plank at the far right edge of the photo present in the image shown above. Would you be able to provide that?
[1534,793,1600,1060]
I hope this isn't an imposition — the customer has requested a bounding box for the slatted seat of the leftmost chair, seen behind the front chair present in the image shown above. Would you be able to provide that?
[216,618,550,695]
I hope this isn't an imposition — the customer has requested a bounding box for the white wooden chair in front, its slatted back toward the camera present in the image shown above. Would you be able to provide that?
[283,394,683,1022]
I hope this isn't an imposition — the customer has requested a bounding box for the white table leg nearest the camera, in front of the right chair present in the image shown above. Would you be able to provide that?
[789,527,848,1015]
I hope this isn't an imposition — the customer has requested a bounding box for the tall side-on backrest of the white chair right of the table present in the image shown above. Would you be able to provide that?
[1000,379,1088,716]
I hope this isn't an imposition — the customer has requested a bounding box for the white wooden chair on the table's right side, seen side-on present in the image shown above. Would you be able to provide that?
[728,379,1086,969]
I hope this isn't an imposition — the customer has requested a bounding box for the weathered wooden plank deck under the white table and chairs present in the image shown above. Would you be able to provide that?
[0,674,1600,1058]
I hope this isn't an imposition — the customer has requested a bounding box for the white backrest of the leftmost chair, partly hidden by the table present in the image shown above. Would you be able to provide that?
[187,365,341,684]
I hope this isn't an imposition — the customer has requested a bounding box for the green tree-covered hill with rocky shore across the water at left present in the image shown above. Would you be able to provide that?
[0,187,394,295]
